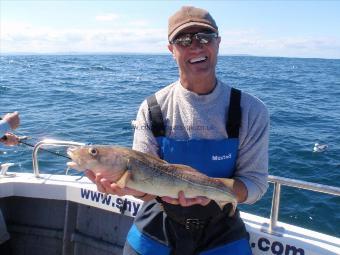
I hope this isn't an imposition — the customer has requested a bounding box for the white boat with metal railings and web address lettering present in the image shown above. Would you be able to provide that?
[0,139,340,255]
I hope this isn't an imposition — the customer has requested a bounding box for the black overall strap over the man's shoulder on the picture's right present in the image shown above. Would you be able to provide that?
[226,88,242,138]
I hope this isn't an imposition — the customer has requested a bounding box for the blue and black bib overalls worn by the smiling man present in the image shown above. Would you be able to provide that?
[124,89,252,255]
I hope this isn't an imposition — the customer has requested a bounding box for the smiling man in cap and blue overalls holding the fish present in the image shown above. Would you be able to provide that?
[88,7,269,255]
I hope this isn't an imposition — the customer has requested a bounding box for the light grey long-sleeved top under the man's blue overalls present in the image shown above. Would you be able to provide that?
[133,78,269,204]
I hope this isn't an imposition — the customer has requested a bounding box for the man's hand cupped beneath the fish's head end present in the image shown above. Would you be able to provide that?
[85,170,145,197]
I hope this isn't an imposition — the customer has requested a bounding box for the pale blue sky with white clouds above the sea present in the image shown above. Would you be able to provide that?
[0,0,340,59]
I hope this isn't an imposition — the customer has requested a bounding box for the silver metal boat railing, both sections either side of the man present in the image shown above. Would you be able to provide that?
[32,139,340,236]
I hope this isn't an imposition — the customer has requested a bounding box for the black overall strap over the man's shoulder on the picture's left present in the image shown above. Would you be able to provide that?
[146,94,165,137]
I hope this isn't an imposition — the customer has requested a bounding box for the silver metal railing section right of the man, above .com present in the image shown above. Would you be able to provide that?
[263,175,340,236]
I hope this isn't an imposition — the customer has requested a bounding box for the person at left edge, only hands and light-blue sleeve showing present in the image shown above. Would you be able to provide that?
[0,112,20,146]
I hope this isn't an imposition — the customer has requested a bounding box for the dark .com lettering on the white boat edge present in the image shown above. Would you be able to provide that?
[251,237,305,255]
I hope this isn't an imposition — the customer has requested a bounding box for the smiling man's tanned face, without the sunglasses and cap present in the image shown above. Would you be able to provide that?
[168,28,221,82]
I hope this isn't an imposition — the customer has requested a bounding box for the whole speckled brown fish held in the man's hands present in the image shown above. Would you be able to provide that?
[67,145,237,216]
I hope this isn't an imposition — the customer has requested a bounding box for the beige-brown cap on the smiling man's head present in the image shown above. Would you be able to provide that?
[168,6,218,42]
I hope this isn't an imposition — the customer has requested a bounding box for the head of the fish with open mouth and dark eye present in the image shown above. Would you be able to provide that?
[67,145,128,181]
